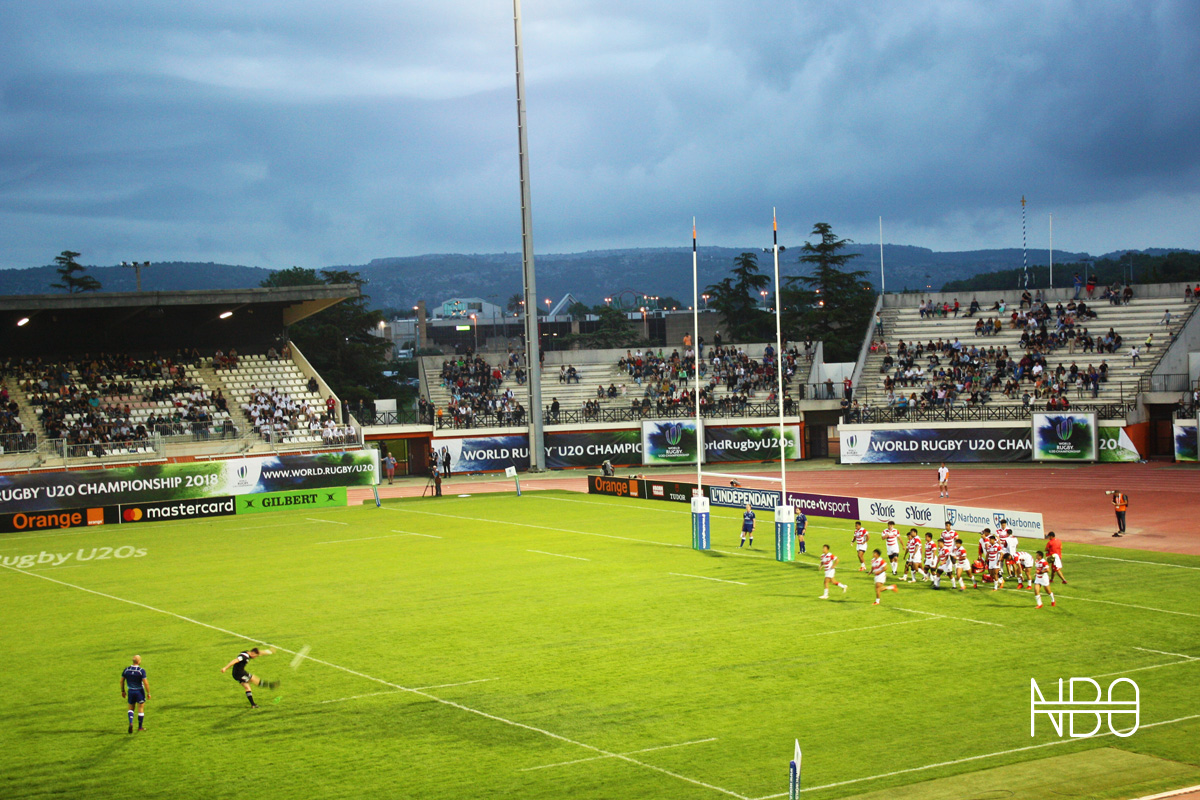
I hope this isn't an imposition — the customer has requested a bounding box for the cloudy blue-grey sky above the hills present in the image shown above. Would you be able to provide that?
[0,0,1200,267]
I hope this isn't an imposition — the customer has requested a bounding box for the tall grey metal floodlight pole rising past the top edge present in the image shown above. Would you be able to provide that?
[512,0,546,473]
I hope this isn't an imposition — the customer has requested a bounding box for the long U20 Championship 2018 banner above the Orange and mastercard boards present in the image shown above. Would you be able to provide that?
[0,449,379,513]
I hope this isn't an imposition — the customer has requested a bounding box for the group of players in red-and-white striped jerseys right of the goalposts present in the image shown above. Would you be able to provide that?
[821,519,1067,608]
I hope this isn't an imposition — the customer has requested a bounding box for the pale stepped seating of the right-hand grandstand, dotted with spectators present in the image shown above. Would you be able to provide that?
[856,295,1195,420]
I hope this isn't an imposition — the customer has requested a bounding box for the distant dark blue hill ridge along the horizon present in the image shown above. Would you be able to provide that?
[0,245,1190,308]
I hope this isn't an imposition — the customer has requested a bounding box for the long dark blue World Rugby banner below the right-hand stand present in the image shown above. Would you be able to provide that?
[839,425,1027,464]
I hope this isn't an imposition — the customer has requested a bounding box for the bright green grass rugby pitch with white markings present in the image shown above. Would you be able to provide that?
[0,492,1200,800]
